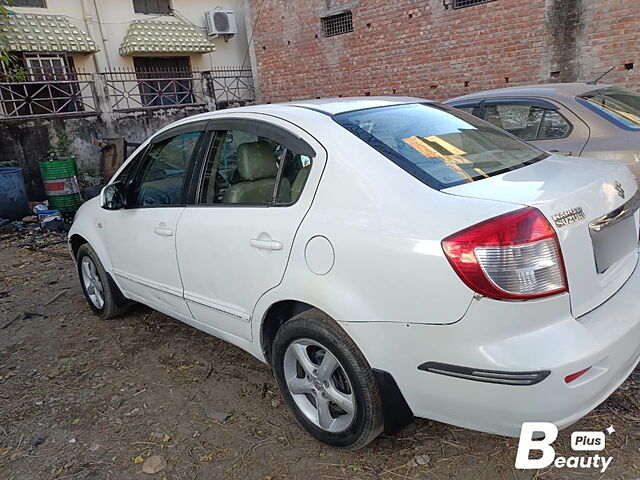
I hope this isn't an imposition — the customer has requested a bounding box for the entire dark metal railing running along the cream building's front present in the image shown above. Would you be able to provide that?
[0,68,255,120]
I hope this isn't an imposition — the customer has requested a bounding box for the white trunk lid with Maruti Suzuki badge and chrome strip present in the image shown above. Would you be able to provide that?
[443,155,640,318]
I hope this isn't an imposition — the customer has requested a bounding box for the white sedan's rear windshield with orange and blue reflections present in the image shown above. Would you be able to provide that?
[333,103,548,190]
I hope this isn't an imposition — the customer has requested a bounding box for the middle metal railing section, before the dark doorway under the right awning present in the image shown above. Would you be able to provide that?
[102,69,206,112]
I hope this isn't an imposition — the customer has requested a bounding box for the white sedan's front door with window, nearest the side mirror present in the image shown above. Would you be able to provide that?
[105,132,202,317]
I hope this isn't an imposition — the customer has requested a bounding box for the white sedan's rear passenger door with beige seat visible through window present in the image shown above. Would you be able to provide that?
[177,119,325,340]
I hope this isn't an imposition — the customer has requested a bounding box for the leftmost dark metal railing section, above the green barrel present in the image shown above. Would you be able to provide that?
[0,73,100,119]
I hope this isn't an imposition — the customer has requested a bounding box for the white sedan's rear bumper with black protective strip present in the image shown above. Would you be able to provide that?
[342,253,640,436]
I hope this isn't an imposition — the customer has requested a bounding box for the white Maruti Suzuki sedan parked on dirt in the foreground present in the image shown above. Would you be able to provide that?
[69,98,640,449]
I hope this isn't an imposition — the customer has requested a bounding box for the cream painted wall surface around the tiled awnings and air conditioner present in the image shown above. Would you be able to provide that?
[12,0,250,72]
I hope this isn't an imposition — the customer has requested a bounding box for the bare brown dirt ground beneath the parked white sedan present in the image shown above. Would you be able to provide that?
[0,231,640,480]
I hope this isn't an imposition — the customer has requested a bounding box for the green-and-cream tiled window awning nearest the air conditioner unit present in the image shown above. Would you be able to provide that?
[120,20,216,56]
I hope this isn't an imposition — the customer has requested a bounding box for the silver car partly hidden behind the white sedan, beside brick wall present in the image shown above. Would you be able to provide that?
[445,83,640,178]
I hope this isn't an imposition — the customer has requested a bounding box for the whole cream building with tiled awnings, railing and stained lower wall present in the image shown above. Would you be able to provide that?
[0,0,255,200]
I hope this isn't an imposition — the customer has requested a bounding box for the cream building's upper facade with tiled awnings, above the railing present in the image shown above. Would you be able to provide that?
[0,0,248,72]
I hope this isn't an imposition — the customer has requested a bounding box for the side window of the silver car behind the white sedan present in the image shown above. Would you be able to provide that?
[484,103,571,140]
